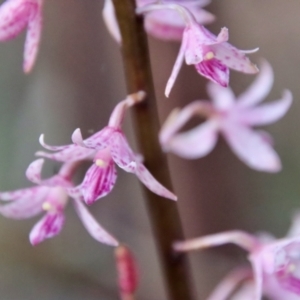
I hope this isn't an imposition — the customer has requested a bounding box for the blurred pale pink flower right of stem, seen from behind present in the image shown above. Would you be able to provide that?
[160,62,292,172]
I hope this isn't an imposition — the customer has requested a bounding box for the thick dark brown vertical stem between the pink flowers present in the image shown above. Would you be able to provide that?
[113,0,192,300]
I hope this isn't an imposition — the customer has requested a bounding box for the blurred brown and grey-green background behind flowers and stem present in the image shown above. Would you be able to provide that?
[0,0,300,300]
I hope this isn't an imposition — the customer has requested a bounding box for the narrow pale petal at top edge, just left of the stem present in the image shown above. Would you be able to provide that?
[102,0,122,44]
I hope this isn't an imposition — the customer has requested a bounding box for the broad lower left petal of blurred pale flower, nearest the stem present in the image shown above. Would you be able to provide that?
[164,121,218,159]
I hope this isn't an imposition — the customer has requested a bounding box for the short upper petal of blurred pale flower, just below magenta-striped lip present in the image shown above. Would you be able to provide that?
[207,82,235,110]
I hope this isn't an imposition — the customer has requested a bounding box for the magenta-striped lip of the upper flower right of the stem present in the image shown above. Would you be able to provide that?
[195,58,229,87]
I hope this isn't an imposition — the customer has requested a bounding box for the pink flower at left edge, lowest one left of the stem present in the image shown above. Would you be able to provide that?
[0,159,119,246]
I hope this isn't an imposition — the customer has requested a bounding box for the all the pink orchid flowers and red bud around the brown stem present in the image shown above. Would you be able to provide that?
[0,0,300,300]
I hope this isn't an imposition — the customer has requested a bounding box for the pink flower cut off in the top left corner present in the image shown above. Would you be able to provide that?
[0,0,43,73]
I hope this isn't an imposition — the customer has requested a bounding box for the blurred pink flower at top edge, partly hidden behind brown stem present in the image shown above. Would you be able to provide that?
[103,0,215,43]
